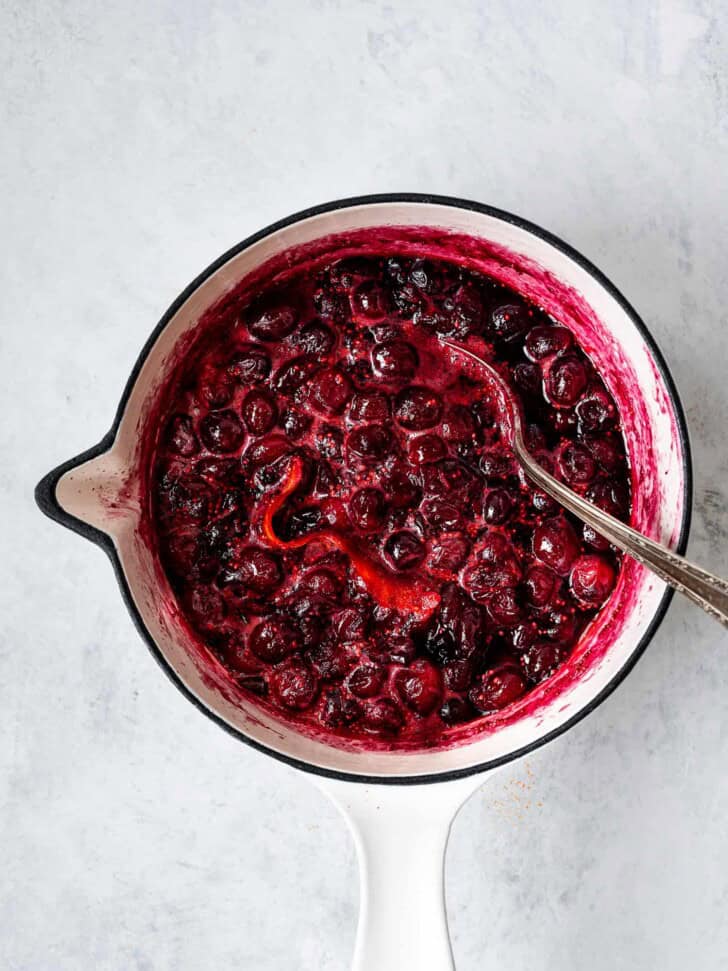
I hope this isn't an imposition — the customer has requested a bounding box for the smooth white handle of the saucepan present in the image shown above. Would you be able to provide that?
[321,775,483,971]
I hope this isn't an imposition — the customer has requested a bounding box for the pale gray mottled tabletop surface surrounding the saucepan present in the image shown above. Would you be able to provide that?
[5,0,728,971]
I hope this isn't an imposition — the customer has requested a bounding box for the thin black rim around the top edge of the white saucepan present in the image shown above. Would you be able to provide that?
[35,192,693,785]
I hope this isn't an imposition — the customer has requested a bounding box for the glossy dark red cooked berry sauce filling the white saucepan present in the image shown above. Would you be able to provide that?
[153,255,630,745]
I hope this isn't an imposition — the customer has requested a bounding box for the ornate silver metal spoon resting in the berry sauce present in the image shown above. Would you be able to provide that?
[441,339,728,627]
